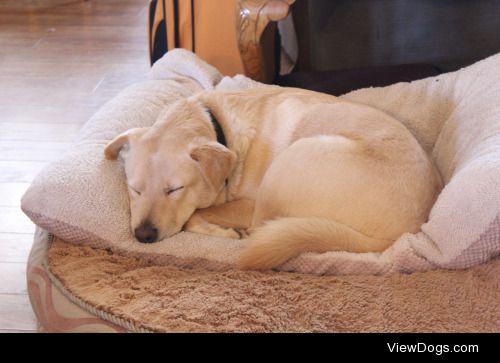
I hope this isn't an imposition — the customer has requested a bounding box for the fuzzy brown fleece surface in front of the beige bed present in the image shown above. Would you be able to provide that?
[48,238,500,332]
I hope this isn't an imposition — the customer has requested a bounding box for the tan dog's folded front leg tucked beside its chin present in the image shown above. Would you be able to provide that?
[184,199,255,239]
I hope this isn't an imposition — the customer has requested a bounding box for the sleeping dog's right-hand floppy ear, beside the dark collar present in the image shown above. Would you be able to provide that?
[190,142,236,191]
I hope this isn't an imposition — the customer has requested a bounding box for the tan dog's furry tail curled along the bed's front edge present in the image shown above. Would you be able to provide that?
[238,217,394,270]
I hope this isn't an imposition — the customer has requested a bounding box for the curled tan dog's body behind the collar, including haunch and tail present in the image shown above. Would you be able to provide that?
[195,87,441,269]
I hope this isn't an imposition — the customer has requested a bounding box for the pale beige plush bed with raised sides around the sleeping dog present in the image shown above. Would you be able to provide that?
[22,50,500,274]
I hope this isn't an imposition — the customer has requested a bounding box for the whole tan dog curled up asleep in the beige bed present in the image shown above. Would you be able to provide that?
[105,87,442,269]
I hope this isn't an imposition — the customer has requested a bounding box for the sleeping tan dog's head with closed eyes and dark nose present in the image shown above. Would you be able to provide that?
[104,100,236,243]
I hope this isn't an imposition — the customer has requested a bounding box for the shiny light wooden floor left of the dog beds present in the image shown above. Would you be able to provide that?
[0,0,149,332]
